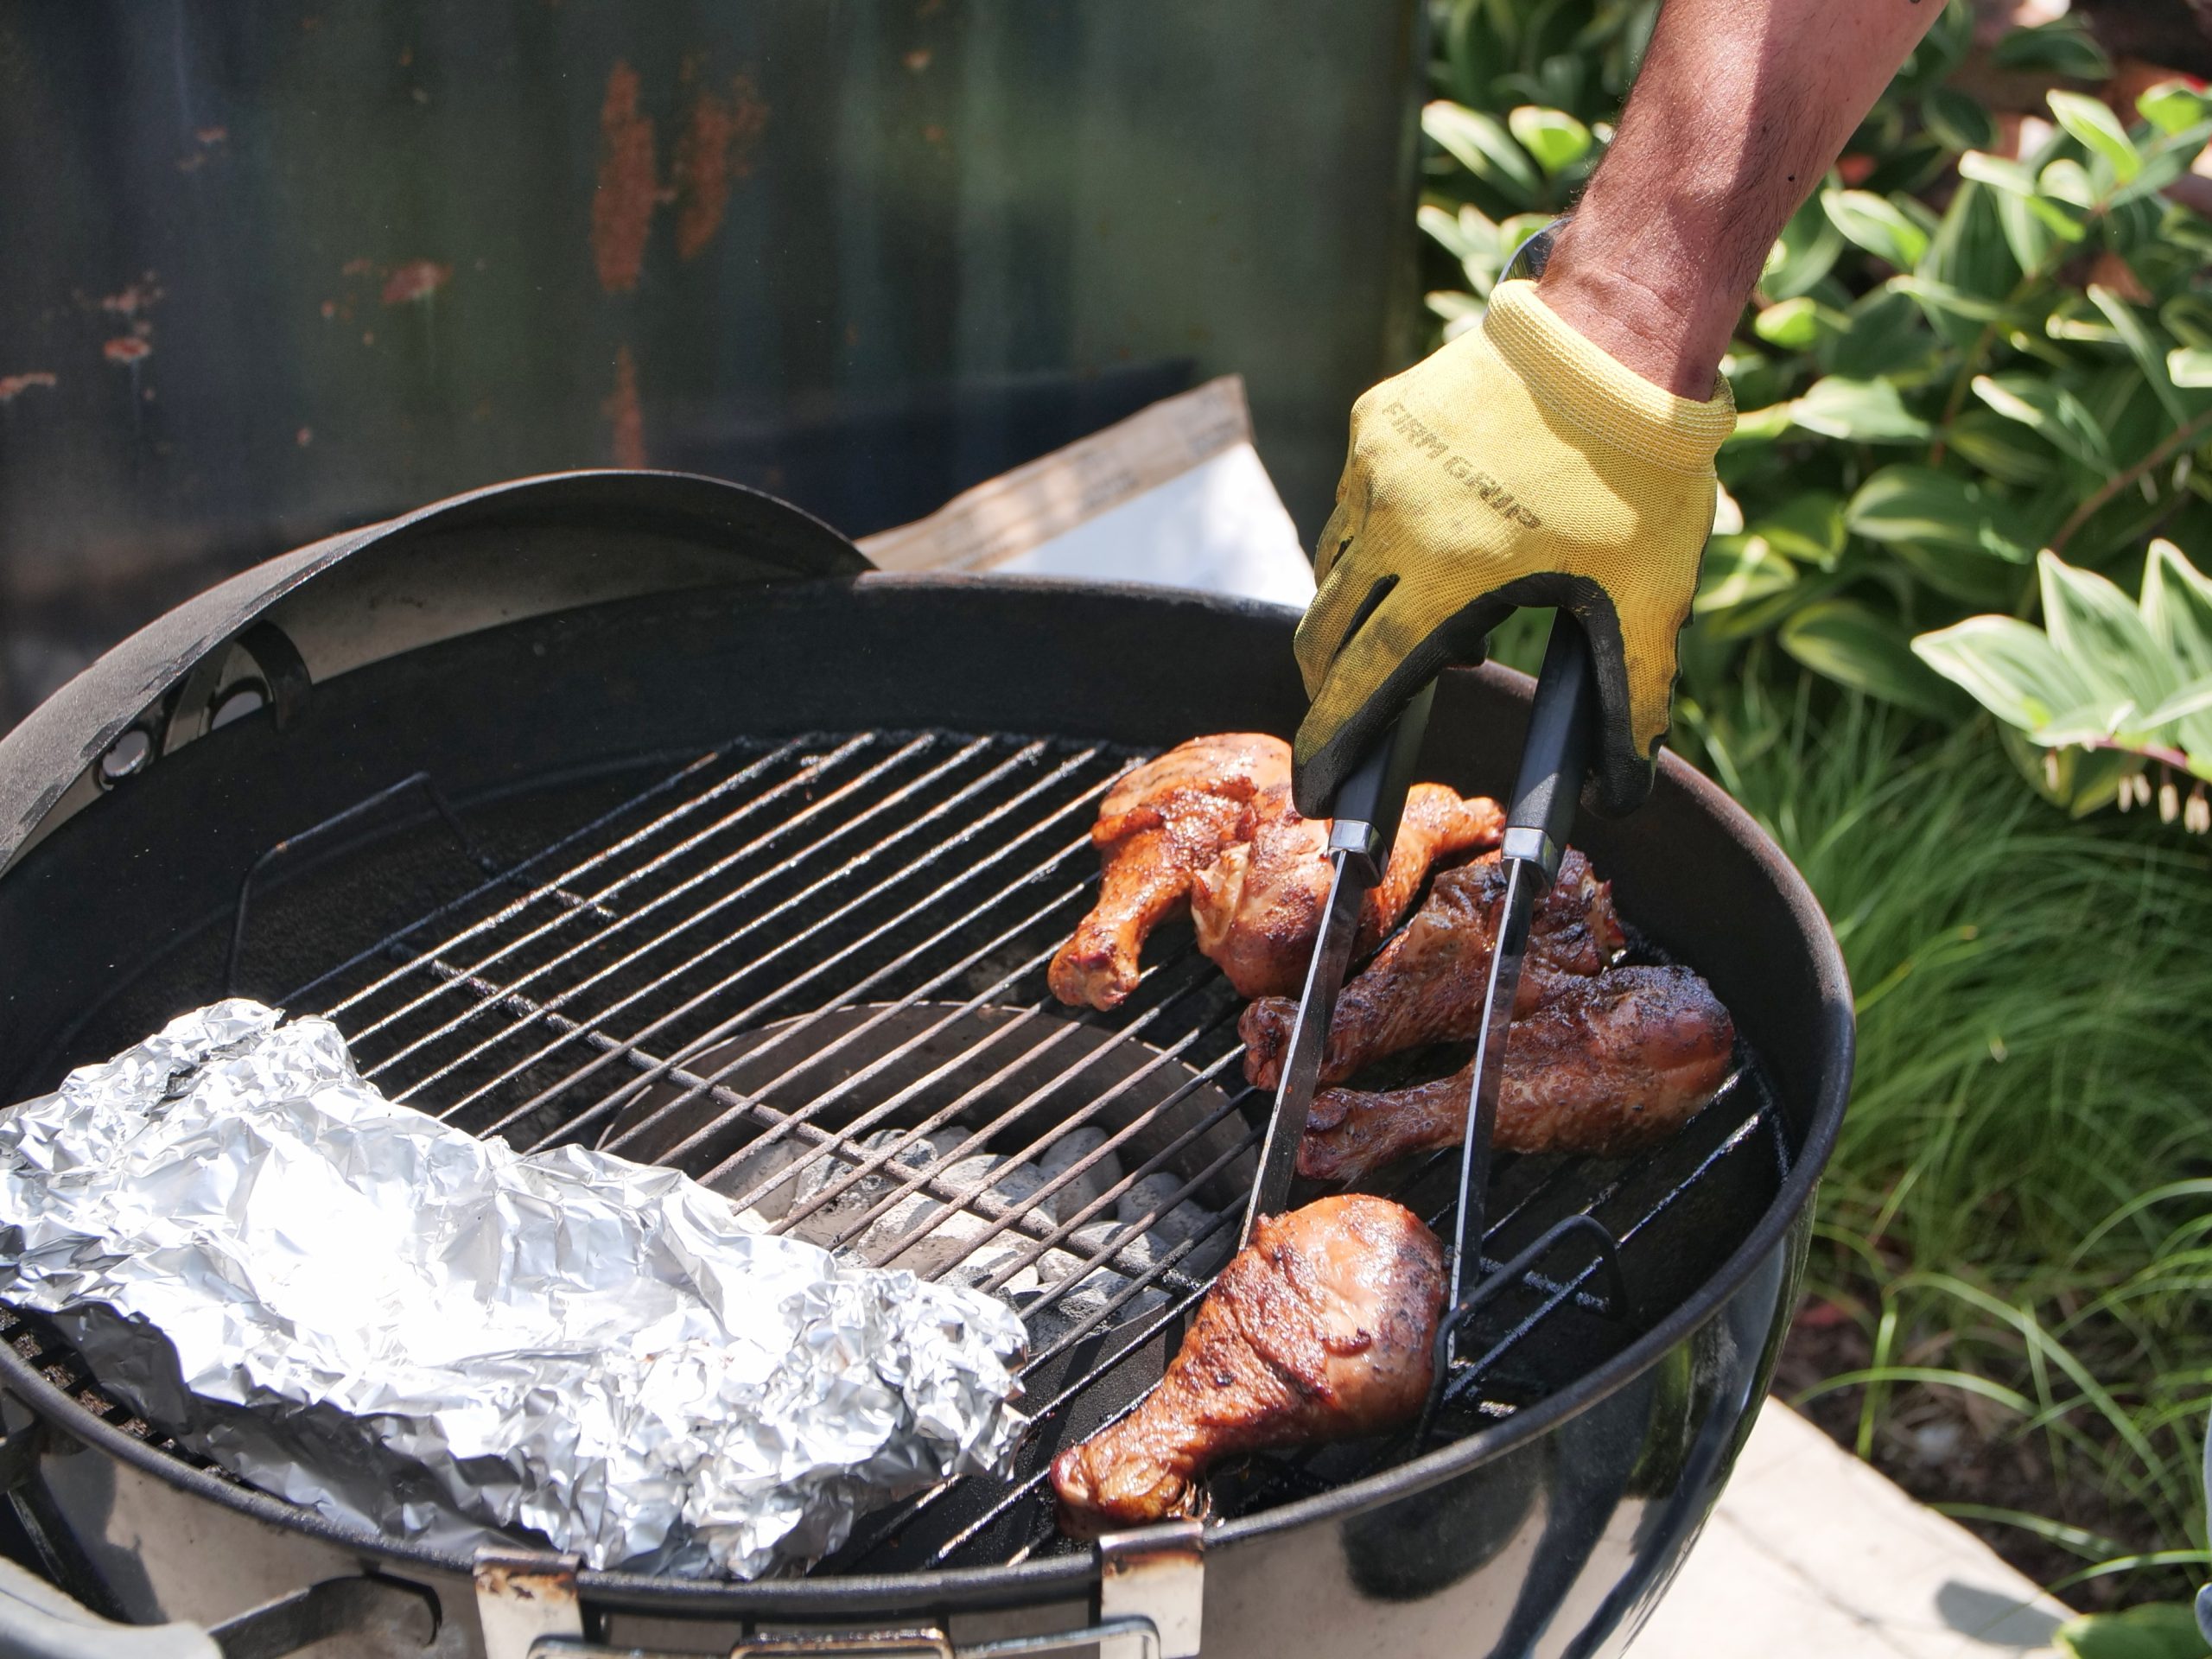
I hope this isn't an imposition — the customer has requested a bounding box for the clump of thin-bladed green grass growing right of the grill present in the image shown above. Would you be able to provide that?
[1683,685,2212,1606]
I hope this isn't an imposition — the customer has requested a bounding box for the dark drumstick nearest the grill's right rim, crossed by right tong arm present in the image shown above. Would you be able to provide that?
[1299,967,1737,1181]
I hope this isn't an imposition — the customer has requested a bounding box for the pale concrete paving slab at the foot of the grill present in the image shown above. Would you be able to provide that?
[1630,1400,2073,1659]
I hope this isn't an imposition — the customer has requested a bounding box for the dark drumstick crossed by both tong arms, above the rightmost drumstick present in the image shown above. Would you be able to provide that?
[1236,847,1626,1089]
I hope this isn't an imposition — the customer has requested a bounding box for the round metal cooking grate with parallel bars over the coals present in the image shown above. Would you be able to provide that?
[17,732,1789,1573]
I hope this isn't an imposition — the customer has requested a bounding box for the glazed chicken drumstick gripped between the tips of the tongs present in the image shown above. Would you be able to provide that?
[1053,1194,1445,1537]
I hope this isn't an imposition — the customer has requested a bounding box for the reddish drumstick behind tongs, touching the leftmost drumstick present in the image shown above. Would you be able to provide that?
[1190,783,1506,998]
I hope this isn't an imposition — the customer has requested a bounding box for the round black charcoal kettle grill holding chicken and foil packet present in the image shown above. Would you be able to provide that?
[0,474,1852,1659]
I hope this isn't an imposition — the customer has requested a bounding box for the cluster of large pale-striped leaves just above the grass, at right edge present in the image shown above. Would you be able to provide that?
[1913,540,2212,834]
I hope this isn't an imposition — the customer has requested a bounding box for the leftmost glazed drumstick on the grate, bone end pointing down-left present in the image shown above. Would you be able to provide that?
[1046,732,1289,1008]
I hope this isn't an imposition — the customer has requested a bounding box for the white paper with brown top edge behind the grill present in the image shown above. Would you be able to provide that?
[861,376,1314,608]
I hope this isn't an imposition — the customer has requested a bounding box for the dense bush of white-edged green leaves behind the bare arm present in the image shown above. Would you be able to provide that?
[1421,0,2212,827]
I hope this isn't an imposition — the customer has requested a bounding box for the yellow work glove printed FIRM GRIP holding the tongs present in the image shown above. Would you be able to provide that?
[1296,281,1737,817]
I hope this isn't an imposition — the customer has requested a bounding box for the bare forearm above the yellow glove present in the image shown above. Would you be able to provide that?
[1540,0,1942,398]
